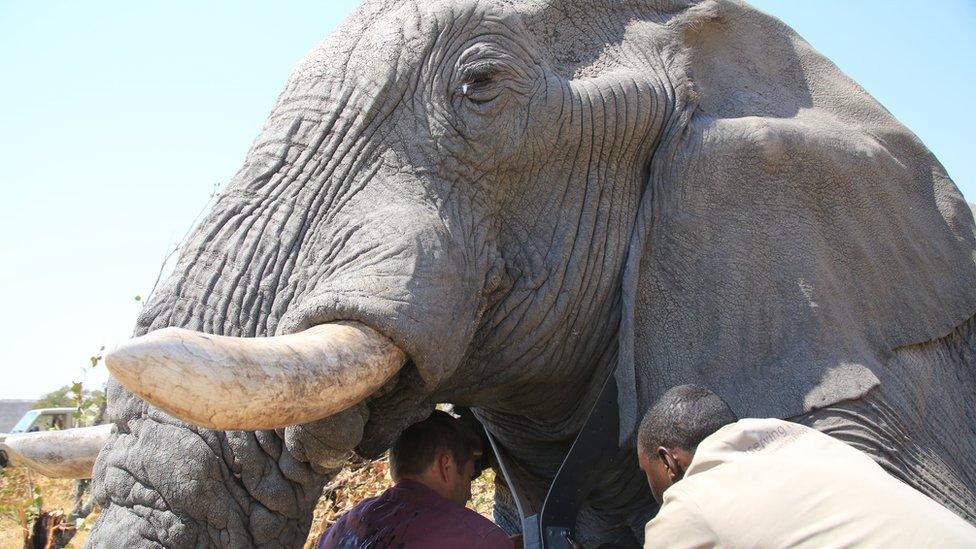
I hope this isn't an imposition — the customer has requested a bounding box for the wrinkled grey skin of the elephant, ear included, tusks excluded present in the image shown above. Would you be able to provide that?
[89,0,976,547]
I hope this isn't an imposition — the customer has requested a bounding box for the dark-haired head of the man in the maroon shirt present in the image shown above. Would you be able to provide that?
[390,410,481,505]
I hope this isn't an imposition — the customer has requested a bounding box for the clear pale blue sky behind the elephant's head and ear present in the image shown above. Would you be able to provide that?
[0,0,976,398]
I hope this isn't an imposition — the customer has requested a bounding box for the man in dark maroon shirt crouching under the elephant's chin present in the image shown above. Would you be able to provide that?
[318,411,515,549]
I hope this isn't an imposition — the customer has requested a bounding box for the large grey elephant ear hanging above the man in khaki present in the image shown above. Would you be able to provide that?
[616,1,976,444]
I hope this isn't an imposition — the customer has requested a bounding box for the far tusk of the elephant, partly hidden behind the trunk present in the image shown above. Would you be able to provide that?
[3,423,113,478]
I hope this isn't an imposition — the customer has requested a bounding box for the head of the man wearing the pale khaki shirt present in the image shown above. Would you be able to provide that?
[637,385,738,504]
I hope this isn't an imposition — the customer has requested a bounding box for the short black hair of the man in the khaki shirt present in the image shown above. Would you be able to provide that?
[637,385,738,455]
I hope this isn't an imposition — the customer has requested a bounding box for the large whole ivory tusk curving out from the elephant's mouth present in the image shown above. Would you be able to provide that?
[105,322,406,431]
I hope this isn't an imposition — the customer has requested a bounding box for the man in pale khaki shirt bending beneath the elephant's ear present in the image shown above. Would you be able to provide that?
[637,385,976,548]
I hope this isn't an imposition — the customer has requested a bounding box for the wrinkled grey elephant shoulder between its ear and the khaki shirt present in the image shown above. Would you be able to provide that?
[793,312,976,525]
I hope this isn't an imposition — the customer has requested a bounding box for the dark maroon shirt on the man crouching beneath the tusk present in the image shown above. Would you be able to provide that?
[318,480,514,549]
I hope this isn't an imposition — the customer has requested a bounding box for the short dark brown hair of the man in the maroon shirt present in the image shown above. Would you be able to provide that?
[390,410,481,480]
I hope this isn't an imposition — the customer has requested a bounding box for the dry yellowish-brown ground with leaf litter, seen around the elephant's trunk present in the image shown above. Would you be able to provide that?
[0,458,495,549]
